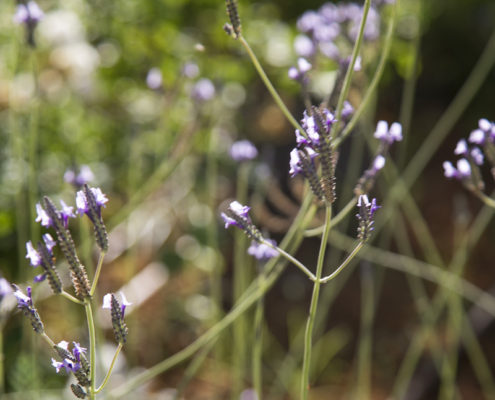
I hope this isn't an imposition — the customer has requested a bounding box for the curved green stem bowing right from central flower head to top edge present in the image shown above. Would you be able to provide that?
[333,0,399,147]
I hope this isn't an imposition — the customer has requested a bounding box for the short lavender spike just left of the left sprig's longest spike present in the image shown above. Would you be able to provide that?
[26,233,62,293]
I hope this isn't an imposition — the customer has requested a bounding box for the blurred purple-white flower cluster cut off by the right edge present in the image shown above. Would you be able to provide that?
[442,118,495,191]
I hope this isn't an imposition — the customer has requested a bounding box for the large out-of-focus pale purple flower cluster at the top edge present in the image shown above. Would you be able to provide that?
[294,3,386,63]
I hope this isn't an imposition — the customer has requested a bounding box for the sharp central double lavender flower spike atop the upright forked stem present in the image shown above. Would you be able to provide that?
[289,107,336,203]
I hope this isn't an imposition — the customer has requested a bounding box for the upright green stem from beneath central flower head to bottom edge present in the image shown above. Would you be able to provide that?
[300,206,332,400]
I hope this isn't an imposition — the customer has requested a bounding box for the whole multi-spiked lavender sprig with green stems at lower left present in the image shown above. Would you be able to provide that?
[8,186,131,399]
